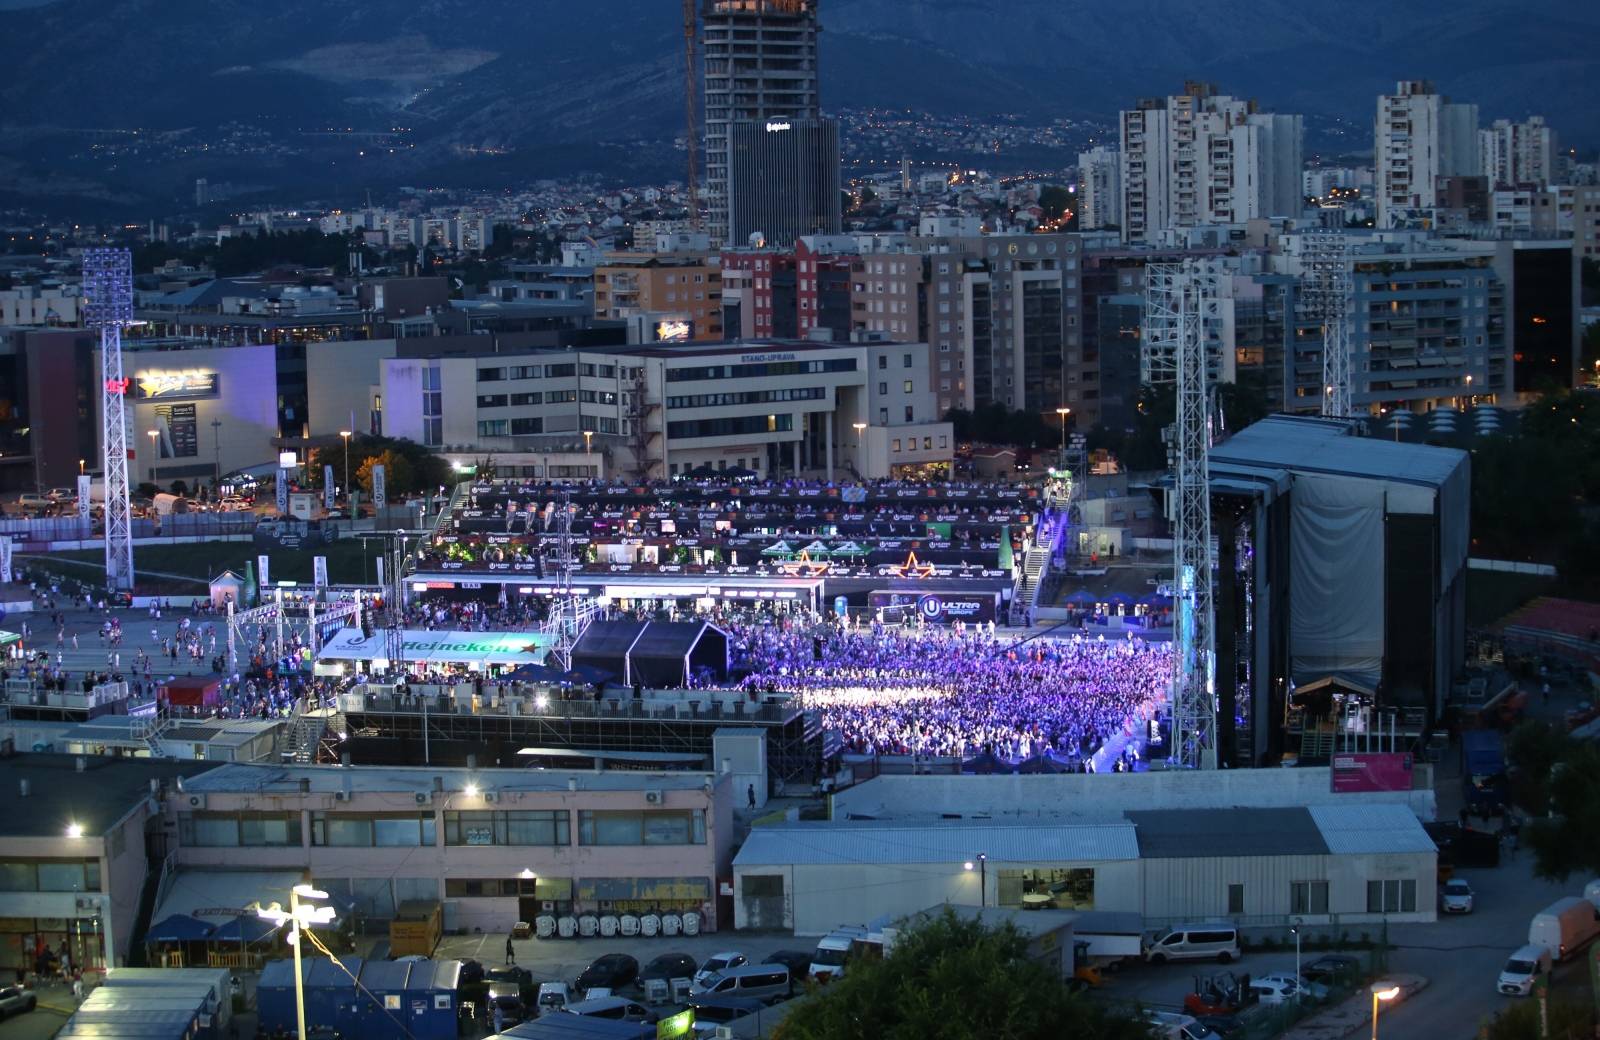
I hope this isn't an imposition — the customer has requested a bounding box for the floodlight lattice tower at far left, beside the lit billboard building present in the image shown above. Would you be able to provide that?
[83,250,134,592]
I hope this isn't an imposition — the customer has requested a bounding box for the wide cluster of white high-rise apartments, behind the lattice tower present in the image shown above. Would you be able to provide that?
[1122,83,1304,242]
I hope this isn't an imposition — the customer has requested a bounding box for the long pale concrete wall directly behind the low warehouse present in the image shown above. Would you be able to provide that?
[834,766,1435,821]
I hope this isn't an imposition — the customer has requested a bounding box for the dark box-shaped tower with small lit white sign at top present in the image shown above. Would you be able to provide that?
[726,118,840,248]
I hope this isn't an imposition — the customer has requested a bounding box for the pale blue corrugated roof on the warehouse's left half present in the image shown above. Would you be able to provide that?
[733,822,1139,867]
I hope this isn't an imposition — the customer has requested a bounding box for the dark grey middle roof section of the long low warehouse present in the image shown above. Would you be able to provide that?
[1128,808,1328,859]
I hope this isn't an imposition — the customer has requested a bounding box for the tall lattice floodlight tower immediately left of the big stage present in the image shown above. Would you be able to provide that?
[1146,261,1218,770]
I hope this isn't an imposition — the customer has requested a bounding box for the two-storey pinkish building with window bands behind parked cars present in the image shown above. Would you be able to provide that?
[162,765,734,931]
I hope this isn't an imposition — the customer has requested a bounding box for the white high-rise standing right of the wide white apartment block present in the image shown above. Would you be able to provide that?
[1373,80,1480,229]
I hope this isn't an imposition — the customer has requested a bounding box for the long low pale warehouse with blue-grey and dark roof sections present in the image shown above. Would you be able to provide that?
[733,787,1437,934]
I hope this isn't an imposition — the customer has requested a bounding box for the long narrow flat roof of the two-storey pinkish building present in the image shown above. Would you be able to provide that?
[184,752,723,794]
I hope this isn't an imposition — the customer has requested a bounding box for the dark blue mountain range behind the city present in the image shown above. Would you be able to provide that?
[0,0,1600,212]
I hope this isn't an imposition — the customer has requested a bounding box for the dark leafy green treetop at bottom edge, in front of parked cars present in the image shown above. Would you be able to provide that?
[773,907,1150,1040]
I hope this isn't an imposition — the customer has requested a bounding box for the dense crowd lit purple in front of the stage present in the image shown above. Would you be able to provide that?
[733,608,1171,765]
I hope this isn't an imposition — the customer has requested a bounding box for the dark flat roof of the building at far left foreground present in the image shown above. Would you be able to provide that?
[0,754,216,838]
